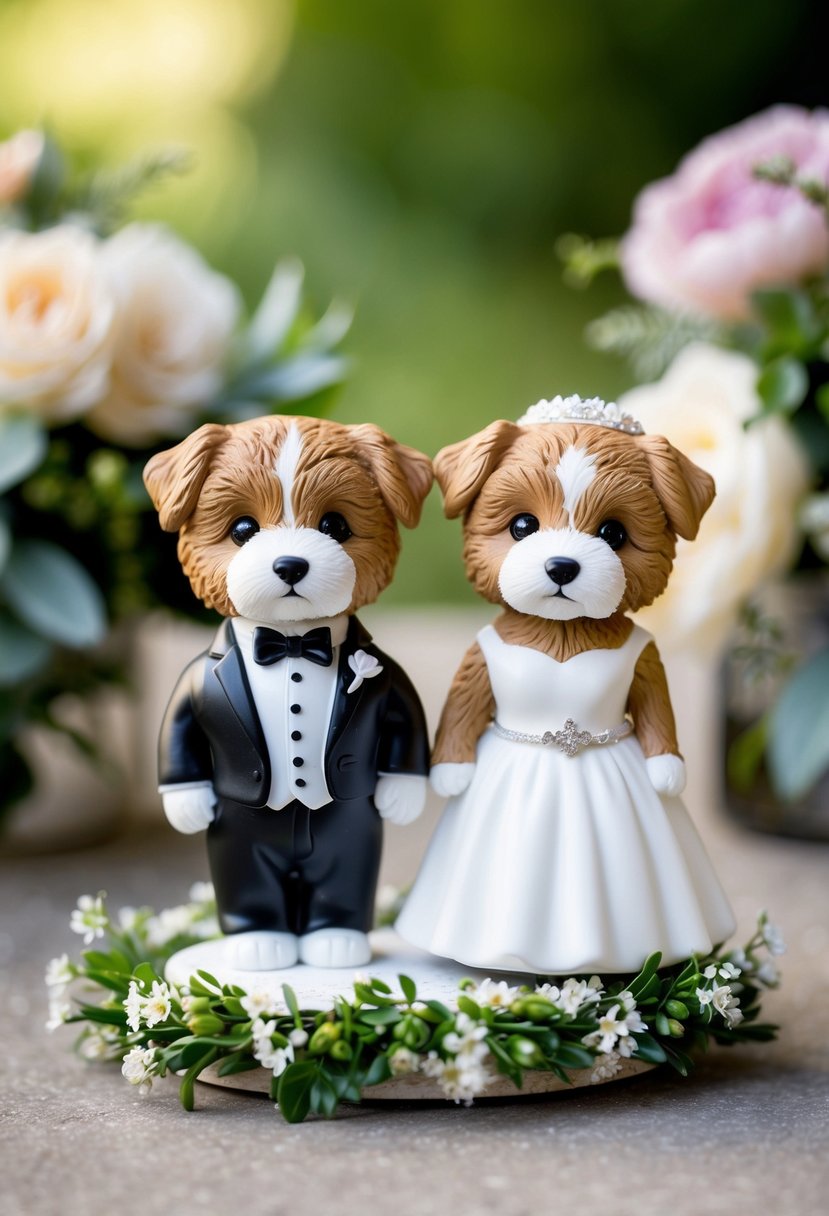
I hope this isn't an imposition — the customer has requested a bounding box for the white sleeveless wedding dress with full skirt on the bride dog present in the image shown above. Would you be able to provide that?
[396,625,734,975]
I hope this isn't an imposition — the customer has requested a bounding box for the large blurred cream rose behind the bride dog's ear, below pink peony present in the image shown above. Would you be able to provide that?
[619,343,810,652]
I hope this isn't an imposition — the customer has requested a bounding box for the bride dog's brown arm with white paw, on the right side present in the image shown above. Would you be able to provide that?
[627,642,686,795]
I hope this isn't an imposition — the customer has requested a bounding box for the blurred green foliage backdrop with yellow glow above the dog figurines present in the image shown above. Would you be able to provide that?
[0,0,824,603]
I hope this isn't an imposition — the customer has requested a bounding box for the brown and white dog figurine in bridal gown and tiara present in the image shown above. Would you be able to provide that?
[397,398,734,974]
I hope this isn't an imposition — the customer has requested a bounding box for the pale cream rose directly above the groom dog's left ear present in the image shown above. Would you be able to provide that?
[86,224,239,446]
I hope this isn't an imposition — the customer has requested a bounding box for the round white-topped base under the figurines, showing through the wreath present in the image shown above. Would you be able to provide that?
[165,929,654,1102]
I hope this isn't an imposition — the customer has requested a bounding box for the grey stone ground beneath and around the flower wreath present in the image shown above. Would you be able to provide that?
[0,612,829,1216]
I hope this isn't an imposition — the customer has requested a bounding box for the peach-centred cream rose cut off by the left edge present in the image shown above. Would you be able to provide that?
[0,225,114,422]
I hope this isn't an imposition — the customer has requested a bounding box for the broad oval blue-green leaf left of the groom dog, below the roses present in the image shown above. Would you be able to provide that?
[0,540,107,649]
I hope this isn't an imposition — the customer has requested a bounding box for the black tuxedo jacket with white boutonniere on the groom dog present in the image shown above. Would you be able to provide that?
[158,617,429,807]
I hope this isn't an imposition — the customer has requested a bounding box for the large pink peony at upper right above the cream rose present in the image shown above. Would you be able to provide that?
[621,106,829,320]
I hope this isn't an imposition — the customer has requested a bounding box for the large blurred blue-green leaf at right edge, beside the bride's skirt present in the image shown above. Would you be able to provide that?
[768,648,829,800]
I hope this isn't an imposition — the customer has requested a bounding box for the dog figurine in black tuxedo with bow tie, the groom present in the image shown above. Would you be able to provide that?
[145,416,432,970]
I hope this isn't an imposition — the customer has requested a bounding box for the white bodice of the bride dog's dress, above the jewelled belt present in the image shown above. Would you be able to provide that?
[478,625,652,734]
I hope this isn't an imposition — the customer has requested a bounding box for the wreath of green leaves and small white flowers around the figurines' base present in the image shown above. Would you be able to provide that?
[46,883,783,1122]
